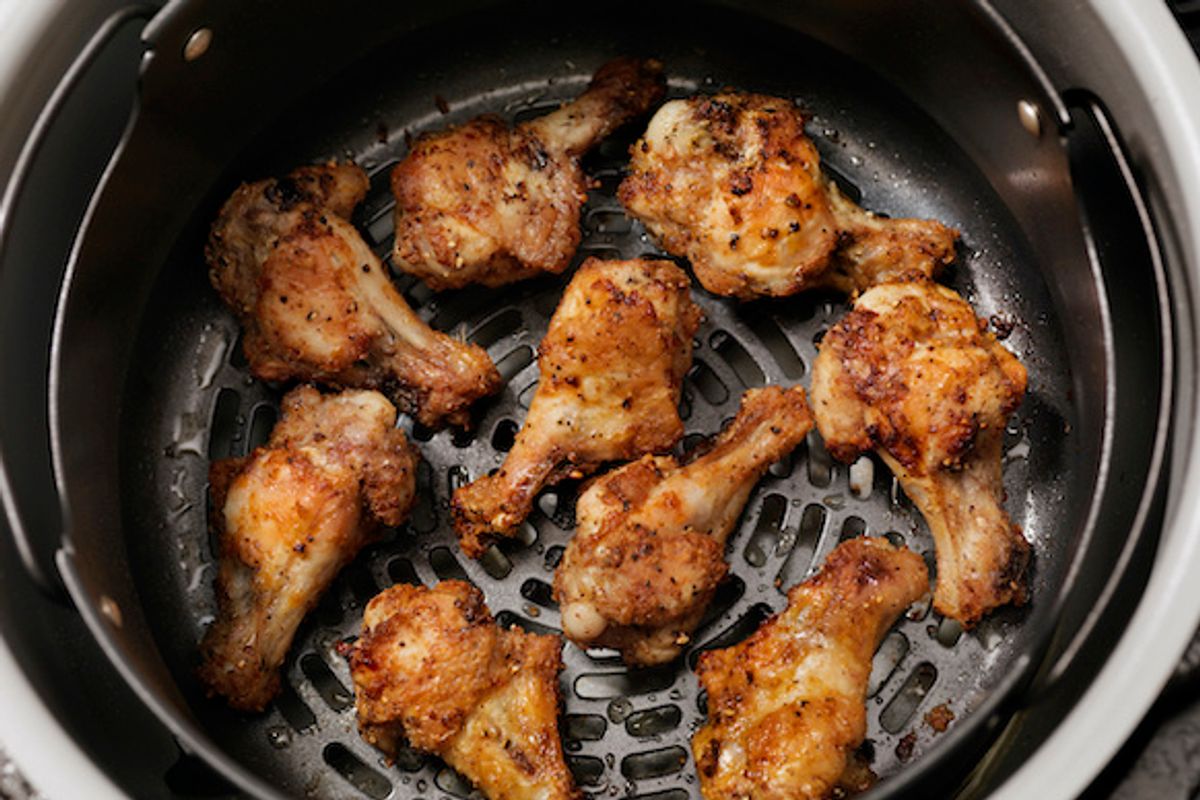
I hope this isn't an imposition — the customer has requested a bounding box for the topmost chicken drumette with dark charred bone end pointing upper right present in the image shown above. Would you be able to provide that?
[391,59,664,289]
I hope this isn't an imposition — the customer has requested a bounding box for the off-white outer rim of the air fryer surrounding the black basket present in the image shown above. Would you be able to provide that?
[0,0,1200,798]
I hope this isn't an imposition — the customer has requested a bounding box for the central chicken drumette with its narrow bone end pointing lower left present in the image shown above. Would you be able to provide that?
[452,258,701,558]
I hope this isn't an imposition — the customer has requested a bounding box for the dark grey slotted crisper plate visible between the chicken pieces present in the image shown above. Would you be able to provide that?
[133,62,1051,800]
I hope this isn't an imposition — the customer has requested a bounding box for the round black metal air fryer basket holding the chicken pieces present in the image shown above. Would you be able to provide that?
[39,2,1169,800]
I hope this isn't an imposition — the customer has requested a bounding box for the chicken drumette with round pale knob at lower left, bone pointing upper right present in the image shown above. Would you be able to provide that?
[554,386,812,666]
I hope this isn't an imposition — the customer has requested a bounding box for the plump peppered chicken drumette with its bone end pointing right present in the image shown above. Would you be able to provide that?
[618,94,958,300]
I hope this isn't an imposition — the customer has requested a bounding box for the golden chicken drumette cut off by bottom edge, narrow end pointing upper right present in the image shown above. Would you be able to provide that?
[691,537,929,800]
